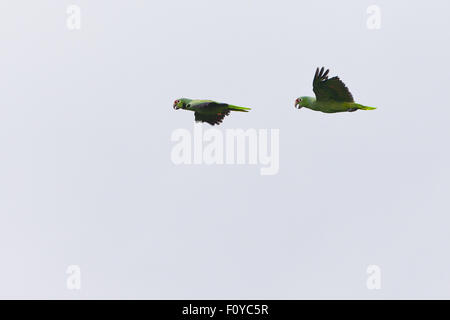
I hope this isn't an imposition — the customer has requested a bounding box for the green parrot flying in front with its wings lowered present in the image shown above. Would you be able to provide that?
[173,98,251,125]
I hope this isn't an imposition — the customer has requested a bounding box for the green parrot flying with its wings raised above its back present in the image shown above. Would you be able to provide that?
[295,67,376,113]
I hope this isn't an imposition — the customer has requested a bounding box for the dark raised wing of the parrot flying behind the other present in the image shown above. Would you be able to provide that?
[313,67,354,102]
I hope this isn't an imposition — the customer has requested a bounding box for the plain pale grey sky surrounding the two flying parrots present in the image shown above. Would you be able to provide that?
[0,0,450,299]
